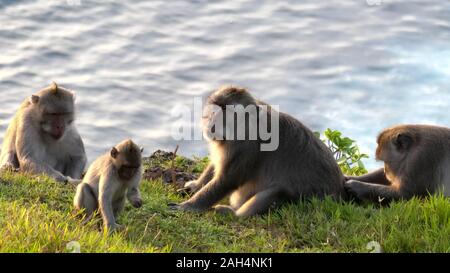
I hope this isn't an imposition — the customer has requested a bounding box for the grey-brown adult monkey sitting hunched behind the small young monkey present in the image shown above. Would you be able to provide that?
[0,83,86,183]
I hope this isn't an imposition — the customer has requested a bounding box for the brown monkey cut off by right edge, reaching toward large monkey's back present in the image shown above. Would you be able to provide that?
[345,125,450,203]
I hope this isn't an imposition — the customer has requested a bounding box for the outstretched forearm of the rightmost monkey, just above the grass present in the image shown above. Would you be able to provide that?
[344,180,402,203]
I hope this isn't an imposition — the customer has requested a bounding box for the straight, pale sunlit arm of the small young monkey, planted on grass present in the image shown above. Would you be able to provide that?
[98,173,118,230]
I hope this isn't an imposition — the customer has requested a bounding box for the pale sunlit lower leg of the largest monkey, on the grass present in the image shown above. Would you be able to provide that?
[236,188,280,217]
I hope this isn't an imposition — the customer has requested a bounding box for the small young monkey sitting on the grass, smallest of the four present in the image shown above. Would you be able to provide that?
[73,140,143,230]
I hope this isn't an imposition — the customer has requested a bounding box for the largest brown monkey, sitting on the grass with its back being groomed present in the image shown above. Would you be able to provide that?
[169,87,345,216]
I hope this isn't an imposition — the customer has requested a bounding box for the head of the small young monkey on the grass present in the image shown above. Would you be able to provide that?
[111,140,144,181]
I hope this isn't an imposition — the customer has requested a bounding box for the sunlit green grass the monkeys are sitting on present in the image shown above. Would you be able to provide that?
[0,167,450,252]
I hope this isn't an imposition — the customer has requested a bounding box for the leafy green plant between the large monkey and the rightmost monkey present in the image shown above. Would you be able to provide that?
[315,128,369,176]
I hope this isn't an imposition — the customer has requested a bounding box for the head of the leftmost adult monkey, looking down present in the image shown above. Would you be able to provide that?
[31,85,75,140]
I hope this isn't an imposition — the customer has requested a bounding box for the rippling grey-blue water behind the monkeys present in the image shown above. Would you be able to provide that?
[0,0,450,167]
